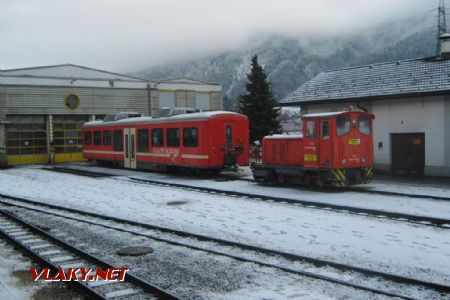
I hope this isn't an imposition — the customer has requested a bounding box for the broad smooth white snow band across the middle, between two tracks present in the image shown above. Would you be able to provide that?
[0,166,450,292]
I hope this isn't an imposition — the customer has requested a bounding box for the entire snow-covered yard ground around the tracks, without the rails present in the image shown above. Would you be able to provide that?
[0,165,450,299]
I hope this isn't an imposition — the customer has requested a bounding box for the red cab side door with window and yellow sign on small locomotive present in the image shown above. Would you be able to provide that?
[303,119,320,168]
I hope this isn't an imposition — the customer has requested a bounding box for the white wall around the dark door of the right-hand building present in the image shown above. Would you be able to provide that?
[301,96,450,176]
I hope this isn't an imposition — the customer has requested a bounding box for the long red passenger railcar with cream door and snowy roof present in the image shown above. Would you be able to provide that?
[83,111,249,170]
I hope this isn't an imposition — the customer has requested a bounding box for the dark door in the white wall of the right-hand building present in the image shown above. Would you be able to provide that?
[391,133,425,175]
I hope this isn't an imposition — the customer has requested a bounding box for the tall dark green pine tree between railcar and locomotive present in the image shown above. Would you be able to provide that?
[239,55,281,142]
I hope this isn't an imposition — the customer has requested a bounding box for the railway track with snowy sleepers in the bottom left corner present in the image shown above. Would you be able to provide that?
[0,210,178,299]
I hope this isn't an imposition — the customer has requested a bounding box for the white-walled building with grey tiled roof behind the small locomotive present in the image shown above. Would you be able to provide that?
[280,39,450,176]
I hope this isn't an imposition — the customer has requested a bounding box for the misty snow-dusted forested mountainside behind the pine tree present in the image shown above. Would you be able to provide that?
[134,13,437,106]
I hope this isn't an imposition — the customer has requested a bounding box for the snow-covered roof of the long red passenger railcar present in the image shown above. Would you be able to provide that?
[84,111,244,126]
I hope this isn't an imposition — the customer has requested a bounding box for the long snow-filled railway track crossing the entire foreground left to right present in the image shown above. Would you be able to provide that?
[0,194,450,299]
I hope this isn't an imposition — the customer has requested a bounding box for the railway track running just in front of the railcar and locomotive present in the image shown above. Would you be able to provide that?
[40,167,450,229]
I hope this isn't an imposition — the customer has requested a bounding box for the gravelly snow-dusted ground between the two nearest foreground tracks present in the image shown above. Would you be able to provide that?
[9,210,390,300]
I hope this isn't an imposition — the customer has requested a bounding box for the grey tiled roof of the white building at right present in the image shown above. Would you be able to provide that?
[280,57,450,104]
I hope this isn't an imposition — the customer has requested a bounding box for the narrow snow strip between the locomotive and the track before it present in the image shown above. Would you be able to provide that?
[59,164,450,219]
